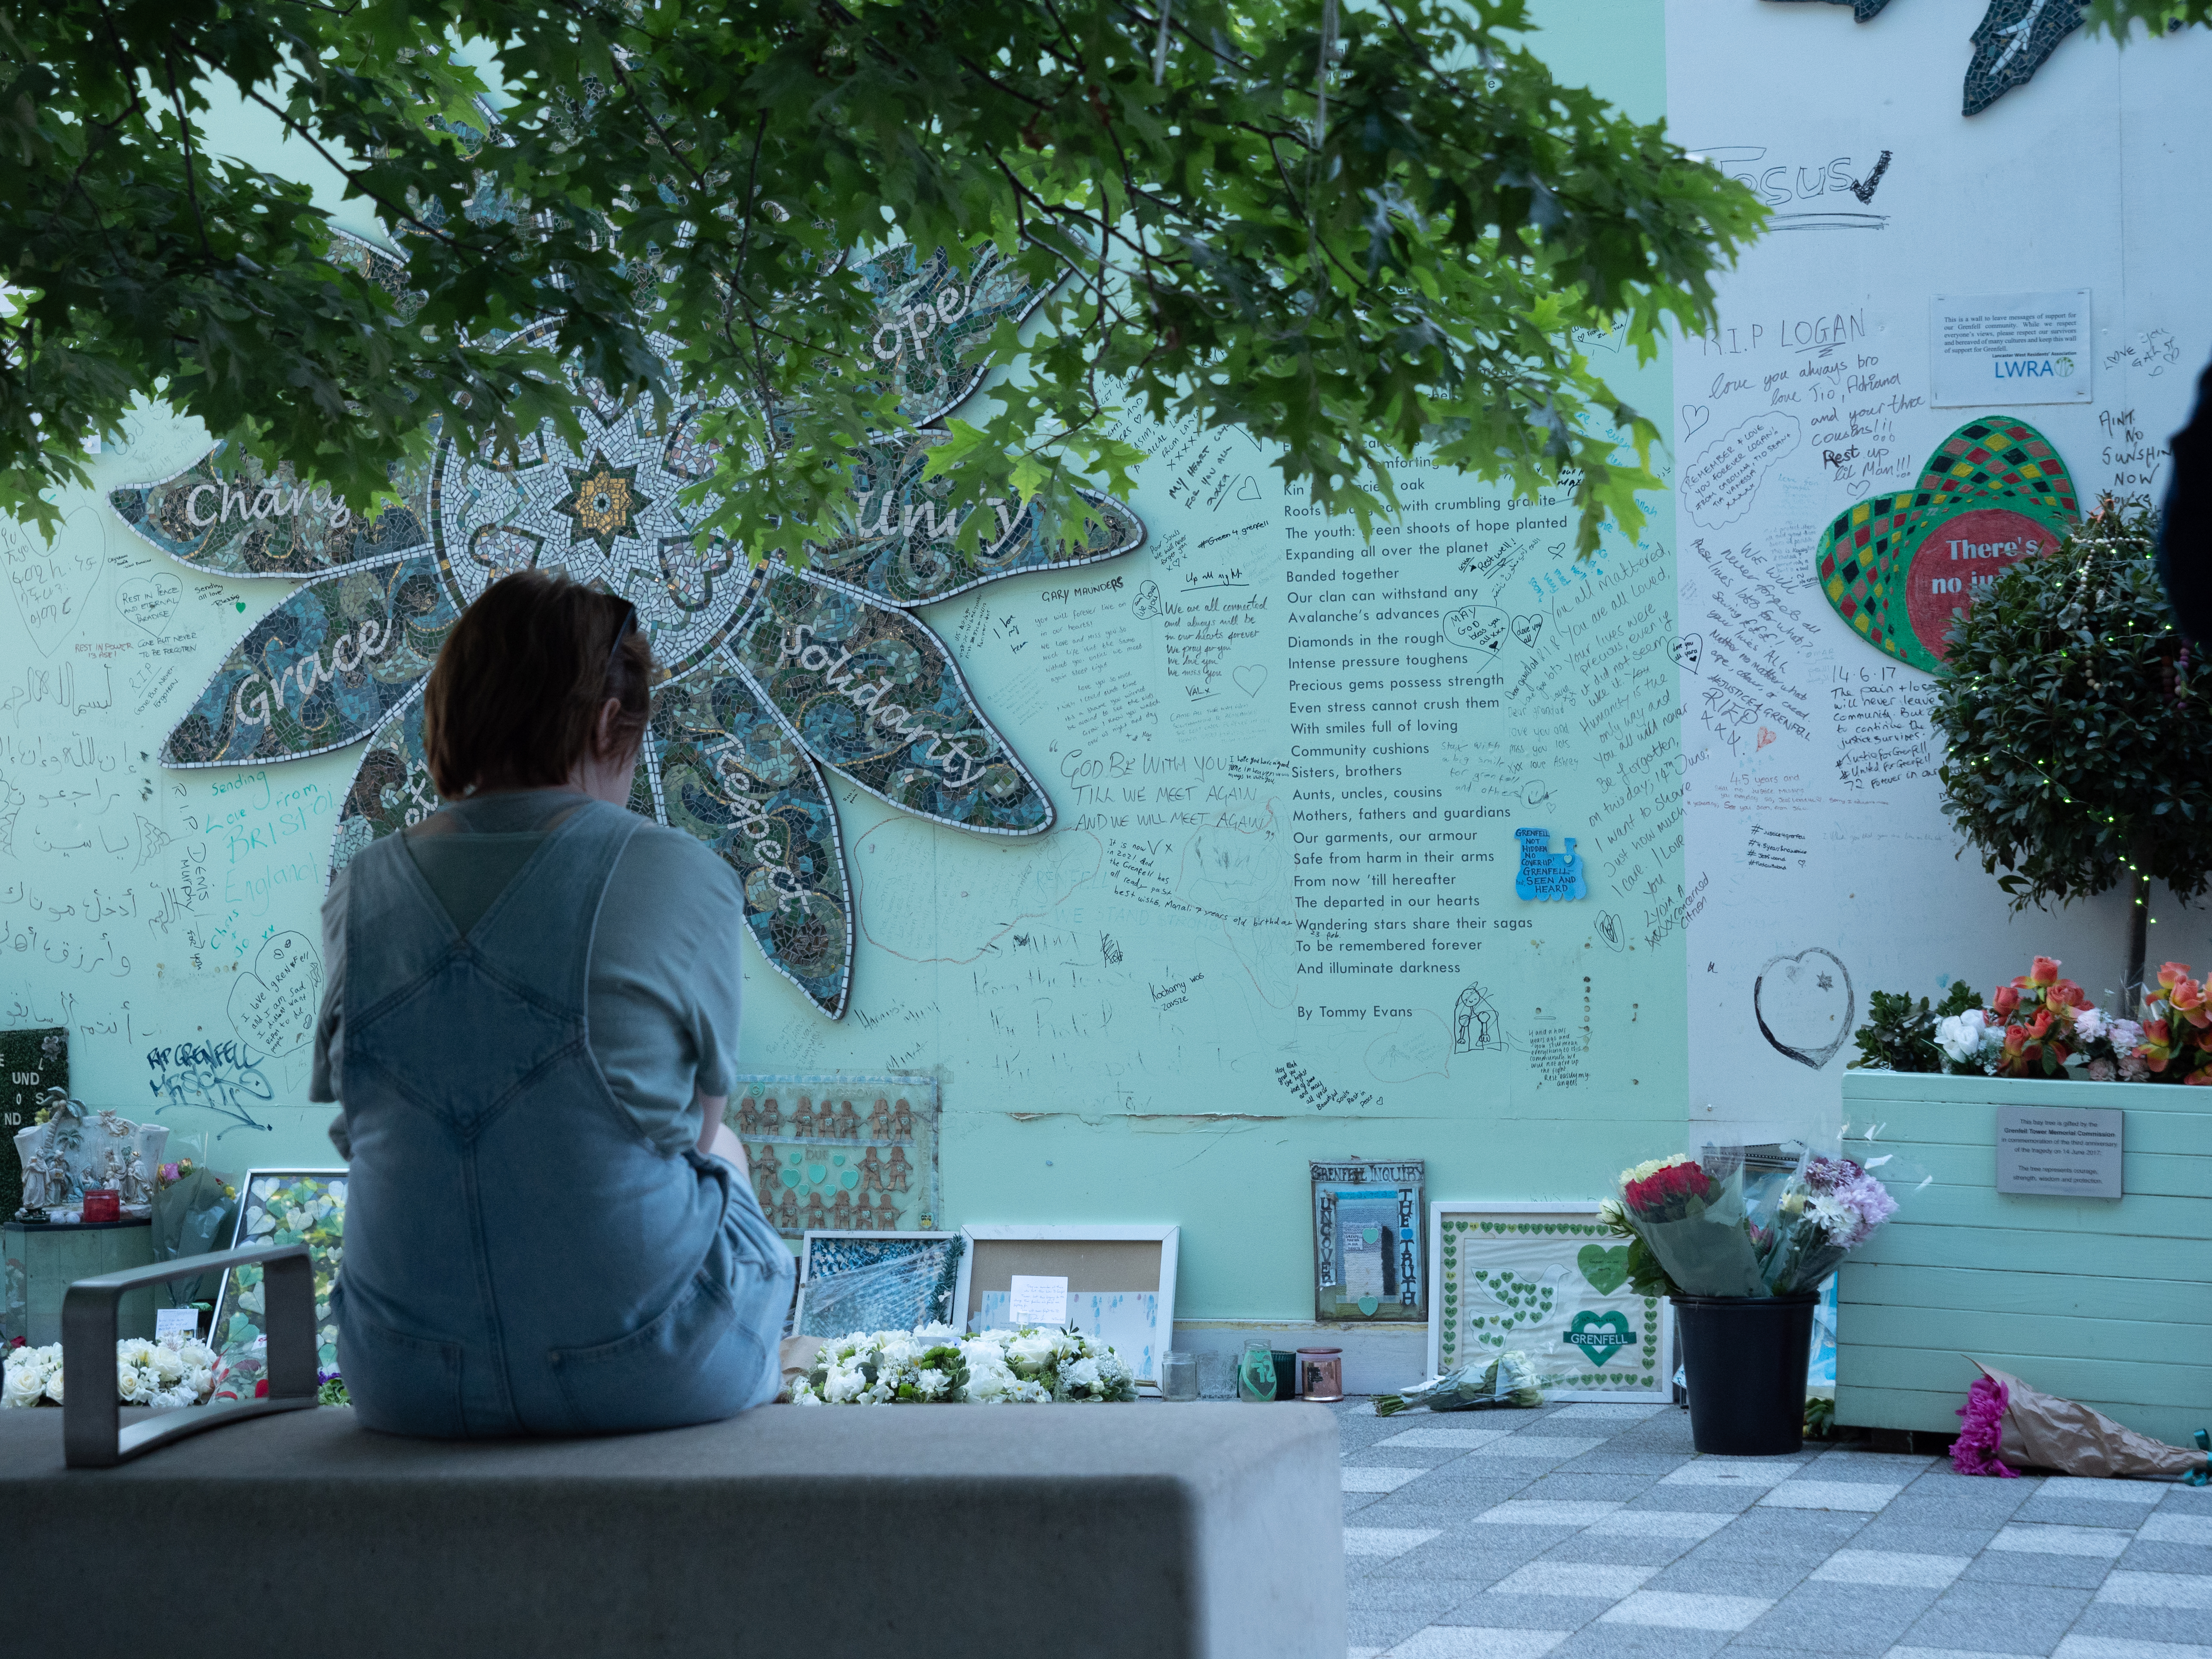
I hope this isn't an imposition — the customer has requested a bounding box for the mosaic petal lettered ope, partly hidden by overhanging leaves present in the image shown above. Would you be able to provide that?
[854,241,1051,427]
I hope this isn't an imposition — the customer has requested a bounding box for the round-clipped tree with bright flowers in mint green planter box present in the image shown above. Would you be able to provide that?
[1836,498,2212,1440]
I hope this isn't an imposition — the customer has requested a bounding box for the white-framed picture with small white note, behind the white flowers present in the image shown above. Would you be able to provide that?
[953,1221,1183,1391]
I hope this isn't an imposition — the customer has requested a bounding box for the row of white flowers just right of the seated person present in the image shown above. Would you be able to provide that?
[792,1325,1137,1405]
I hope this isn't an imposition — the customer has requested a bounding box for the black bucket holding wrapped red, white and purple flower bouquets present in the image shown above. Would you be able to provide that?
[1604,1146,1898,1458]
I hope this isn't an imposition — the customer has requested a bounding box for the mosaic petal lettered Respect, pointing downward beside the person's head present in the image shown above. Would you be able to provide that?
[639,652,852,1020]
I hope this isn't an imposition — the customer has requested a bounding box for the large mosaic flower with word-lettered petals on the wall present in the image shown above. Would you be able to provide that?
[111,241,1144,1020]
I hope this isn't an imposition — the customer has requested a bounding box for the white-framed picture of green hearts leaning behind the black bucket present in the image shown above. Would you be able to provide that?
[1429,1199,1674,1403]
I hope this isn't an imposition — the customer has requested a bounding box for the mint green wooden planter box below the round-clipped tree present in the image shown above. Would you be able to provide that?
[1836,1071,2212,1444]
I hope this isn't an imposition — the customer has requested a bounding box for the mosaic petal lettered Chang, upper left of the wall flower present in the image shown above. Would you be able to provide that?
[108,445,429,579]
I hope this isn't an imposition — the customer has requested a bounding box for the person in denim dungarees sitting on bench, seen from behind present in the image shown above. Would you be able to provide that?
[310,570,792,1438]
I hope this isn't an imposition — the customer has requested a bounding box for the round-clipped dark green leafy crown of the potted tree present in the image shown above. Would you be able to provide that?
[1936,498,2212,924]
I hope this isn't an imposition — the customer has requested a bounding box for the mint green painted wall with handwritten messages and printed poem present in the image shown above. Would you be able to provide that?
[0,0,1688,1327]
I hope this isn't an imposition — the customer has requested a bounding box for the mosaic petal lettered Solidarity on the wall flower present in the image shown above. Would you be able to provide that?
[734,570,1053,836]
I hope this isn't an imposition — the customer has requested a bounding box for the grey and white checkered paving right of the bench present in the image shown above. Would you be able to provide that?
[1338,1403,2212,1659]
